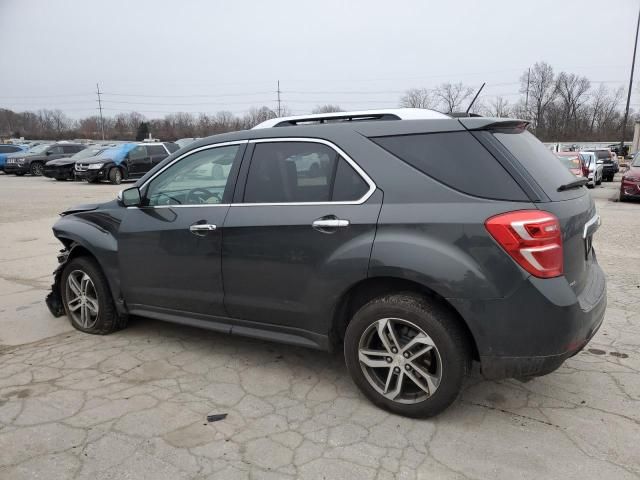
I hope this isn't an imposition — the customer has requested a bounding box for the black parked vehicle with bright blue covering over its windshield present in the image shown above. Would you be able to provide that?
[75,142,179,185]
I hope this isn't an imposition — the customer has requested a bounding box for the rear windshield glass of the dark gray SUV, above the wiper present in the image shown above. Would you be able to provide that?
[494,130,584,200]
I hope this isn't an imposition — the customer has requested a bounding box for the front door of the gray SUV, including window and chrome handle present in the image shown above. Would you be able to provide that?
[118,142,245,319]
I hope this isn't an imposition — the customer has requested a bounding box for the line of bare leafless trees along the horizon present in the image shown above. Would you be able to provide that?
[0,62,635,141]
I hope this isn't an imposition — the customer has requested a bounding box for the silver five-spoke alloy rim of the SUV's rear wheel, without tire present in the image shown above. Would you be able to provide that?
[358,318,442,404]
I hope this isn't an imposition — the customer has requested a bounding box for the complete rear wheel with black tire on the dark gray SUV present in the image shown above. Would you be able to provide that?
[344,293,470,418]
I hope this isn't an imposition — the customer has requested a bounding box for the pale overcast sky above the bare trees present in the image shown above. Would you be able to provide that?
[0,0,640,118]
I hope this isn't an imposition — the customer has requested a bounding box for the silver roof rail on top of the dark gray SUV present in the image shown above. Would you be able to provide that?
[253,108,451,129]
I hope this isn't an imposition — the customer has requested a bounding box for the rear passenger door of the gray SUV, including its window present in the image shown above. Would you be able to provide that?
[222,139,382,344]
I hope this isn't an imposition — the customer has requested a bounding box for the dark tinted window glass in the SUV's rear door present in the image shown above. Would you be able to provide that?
[244,142,368,203]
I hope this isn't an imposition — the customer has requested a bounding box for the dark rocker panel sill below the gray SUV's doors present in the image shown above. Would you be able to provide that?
[129,304,329,350]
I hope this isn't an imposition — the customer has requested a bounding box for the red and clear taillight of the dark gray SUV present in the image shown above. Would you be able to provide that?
[484,210,563,278]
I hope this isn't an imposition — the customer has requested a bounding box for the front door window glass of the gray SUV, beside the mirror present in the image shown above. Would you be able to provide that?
[146,145,240,206]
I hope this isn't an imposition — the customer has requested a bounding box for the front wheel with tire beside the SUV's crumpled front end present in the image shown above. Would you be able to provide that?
[60,257,124,335]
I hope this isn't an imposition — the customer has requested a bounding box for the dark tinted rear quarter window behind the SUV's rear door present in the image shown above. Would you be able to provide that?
[371,132,524,201]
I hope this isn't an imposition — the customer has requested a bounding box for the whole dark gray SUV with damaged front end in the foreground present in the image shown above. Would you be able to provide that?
[47,110,606,417]
